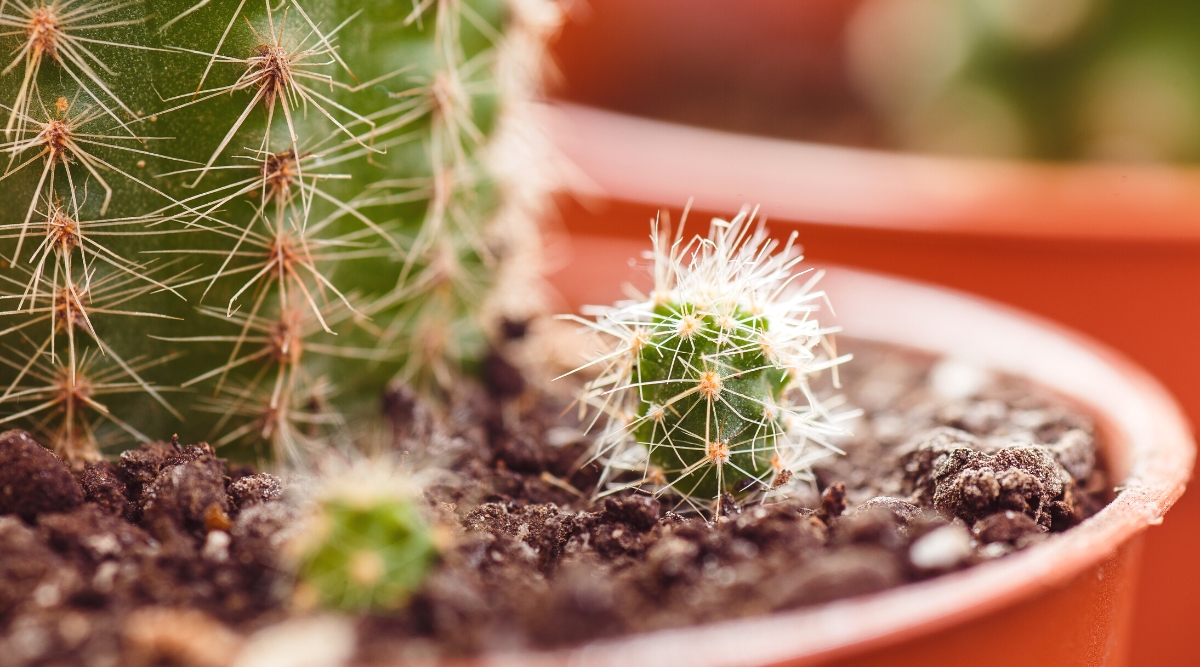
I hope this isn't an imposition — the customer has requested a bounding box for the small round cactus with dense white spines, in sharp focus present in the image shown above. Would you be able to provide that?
[566,209,848,510]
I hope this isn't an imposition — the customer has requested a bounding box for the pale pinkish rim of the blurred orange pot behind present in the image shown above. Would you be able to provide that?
[541,106,1200,242]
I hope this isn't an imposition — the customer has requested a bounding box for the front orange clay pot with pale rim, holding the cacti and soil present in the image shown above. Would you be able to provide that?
[530,236,1195,667]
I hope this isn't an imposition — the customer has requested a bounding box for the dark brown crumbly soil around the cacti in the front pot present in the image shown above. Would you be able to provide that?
[0,342,1110,667]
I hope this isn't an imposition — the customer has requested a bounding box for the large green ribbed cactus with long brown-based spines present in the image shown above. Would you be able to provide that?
[0,0,557,463]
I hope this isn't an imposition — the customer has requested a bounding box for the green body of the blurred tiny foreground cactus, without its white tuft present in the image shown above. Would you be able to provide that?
[296,498,437,611]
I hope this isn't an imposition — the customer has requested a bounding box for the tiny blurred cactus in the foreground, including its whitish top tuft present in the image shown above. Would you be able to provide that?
[288,459,438,612]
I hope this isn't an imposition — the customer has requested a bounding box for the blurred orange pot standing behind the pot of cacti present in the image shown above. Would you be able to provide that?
[547,101,1200,666]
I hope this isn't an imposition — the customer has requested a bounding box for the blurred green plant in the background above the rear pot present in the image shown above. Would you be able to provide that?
[847,0,1200,161]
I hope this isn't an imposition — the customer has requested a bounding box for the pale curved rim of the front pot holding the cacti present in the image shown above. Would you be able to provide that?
[480,259,1195,667]
